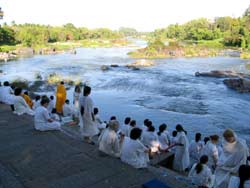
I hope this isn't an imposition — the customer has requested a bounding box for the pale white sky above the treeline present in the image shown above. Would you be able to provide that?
[0,0,250,31]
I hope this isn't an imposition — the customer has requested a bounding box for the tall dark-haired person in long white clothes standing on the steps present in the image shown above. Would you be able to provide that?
[80,86,99,145]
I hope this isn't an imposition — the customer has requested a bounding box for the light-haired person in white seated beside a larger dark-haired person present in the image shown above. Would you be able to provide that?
[98,120,124,157]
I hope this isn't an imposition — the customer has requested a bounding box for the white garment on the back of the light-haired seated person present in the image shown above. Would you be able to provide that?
[98,128,121,157]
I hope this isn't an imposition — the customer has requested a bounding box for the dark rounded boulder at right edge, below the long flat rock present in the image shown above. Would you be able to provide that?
[223,78,250,93]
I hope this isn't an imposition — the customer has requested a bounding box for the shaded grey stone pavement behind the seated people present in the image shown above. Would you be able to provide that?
[0,104,193,188]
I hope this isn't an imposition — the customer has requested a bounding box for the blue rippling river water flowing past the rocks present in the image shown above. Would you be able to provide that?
[0,43,250,145]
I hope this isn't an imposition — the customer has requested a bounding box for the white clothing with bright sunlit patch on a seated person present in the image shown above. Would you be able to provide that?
[142,131,160,152]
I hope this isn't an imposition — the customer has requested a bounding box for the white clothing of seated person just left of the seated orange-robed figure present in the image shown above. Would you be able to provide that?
[14,96,34,115]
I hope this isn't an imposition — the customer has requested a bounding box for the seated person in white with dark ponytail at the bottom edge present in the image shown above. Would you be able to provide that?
[188,155,214,188]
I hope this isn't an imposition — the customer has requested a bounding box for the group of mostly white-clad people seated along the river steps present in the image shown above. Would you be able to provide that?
[0,82,250,188]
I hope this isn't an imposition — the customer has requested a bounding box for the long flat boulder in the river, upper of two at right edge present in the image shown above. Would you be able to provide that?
[195,70,250,78]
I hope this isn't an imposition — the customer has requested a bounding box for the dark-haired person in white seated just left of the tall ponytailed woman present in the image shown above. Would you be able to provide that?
[157,123,170,150]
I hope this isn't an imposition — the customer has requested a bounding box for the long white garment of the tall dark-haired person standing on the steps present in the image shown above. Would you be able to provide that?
[80,96,99,137]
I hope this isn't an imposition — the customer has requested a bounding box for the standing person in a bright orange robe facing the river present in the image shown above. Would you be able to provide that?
[56,82,67,114]
